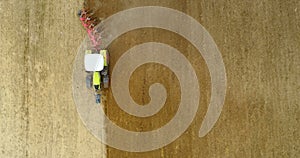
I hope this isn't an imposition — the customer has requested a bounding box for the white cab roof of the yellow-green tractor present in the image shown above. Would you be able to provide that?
[84,54,104,71]
